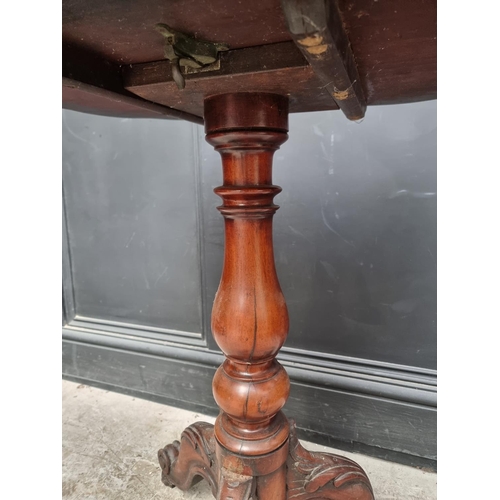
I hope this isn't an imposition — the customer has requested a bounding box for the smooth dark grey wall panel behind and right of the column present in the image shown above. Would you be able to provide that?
[202,101,436,369]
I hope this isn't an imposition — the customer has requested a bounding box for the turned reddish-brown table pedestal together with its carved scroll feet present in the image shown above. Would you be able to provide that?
[159,93,373,500]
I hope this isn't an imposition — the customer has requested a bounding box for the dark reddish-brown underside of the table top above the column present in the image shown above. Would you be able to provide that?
[62,0,437,123]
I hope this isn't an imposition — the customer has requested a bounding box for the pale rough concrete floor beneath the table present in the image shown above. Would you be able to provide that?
[62,381,436,500]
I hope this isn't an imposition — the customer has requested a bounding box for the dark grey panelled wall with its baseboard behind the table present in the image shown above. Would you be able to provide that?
[63,101,436,467]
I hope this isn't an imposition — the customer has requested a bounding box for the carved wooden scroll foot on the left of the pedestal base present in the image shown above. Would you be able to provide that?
[158,422,218,496]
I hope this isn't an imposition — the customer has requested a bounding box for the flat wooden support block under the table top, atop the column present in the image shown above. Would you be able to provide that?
[122,41,338,116]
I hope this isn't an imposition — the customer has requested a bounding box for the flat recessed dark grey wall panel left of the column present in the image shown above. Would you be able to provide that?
[63,111,202,333]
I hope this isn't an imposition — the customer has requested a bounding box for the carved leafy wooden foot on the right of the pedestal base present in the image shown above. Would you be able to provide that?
[287,420,374,500]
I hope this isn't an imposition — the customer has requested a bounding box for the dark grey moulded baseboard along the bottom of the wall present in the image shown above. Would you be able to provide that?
[63,328,436,469]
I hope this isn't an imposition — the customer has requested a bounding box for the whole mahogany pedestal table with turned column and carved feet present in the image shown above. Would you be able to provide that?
[63,0,436,500]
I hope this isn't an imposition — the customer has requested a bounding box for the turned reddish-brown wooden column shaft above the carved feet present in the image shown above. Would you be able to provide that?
[205,93,290,464]
